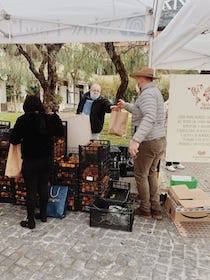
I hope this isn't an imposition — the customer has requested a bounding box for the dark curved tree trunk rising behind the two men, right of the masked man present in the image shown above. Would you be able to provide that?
[105,42,128,102]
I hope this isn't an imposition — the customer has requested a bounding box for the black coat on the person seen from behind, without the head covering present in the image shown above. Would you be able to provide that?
[10,113,64,159]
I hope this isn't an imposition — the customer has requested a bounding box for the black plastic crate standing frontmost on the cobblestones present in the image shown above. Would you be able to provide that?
[90,201,134,232]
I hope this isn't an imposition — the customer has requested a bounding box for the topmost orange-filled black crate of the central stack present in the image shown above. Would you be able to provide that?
[79,140,110,164]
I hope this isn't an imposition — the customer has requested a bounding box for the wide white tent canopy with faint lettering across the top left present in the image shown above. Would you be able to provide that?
[0,0,163,44]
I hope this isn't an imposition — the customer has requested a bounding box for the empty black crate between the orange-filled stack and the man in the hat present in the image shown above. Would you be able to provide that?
[105,180,131,206]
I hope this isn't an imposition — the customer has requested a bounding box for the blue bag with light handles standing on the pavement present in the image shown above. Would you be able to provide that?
[47,186,68,219]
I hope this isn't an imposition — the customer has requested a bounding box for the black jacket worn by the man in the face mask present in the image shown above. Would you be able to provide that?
[77,91,112,133]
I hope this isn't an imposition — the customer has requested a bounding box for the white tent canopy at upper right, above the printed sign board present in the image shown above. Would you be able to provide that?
[151,0,210,70]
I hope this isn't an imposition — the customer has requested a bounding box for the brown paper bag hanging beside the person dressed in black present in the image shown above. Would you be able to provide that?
[5,144,23,178]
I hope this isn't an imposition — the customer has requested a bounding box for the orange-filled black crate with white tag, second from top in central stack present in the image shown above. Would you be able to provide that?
[79,159,110,181]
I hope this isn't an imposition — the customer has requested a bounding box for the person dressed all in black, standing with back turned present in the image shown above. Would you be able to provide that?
[10,95,64,229]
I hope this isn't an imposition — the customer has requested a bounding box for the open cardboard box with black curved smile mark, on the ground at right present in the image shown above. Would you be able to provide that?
[165,185,210,222]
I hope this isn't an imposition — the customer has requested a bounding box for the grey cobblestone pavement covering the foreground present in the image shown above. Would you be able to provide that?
[0,163,210,280]
